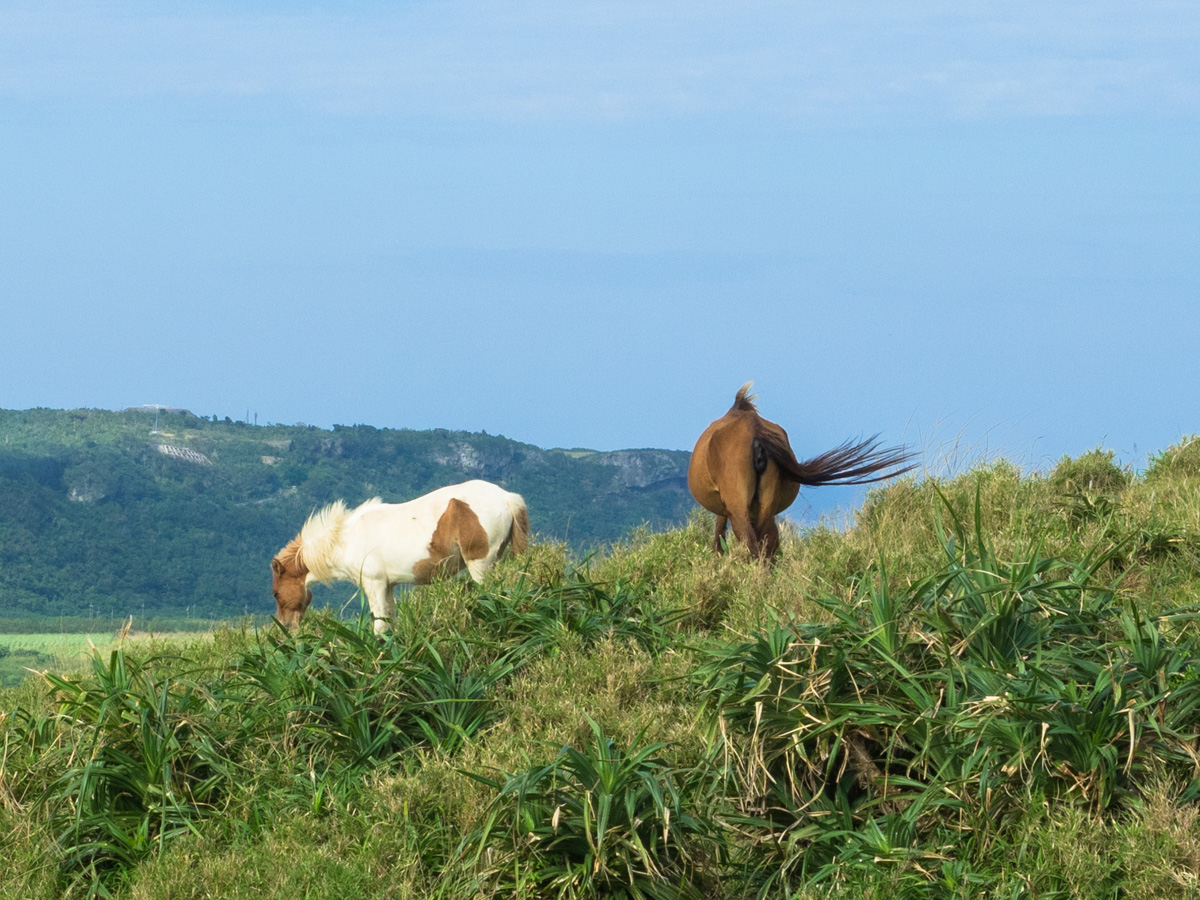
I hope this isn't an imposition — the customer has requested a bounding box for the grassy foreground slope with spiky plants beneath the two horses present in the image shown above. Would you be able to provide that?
[0,439,1200,900]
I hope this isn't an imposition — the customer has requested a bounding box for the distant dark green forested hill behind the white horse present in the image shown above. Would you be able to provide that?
[0,408,694,617]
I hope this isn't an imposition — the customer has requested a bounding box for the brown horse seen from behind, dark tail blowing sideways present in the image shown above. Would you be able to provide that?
[688,382,916,559]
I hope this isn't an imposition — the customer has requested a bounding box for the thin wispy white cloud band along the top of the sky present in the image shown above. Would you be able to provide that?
[0,0,1200,124]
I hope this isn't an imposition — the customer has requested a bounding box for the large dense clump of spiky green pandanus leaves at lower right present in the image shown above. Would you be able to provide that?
[696,489,1200,893]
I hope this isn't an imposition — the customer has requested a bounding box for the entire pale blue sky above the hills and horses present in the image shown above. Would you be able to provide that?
[0,0,1200,511]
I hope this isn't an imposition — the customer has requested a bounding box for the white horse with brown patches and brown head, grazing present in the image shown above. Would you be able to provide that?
[278,481,529,634]
